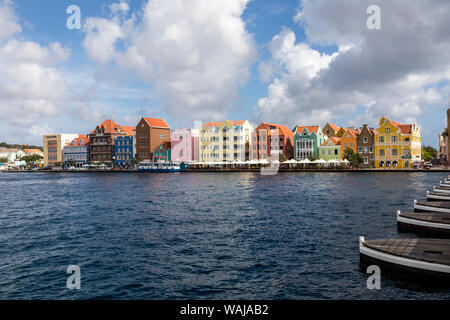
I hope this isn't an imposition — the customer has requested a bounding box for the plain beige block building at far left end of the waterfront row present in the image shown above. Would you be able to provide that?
[43,133,78,167]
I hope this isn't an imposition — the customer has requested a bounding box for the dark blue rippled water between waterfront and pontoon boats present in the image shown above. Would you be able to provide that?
[0,172,450,299]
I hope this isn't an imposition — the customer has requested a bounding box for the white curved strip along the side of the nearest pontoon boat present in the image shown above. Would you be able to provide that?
[359,237,450,274]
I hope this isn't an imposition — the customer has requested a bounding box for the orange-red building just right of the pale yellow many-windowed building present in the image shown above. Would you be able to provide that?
[251,122,294,160]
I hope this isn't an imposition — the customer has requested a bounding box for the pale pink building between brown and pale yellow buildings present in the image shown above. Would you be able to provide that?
[170,129,200,162]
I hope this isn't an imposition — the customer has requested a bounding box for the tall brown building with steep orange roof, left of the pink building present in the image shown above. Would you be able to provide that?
[136,117,170,161]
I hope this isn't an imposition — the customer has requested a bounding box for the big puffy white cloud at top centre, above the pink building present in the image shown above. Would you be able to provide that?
[83,0,255,119]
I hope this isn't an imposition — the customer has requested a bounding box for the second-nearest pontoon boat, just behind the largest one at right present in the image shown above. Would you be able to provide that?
[397,211,450,238]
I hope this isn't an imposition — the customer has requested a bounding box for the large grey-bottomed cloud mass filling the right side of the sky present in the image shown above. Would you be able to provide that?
[255,0,450,136]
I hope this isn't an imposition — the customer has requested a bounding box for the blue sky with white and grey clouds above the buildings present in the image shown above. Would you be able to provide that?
[0,0,450,147]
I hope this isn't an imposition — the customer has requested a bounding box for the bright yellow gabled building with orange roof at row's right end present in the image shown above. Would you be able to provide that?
[375,117,422,169]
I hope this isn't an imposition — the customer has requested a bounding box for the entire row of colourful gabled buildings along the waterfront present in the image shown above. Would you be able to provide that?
[43,117,421,168]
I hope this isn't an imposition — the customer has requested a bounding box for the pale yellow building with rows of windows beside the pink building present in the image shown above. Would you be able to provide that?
[200,120,253,162]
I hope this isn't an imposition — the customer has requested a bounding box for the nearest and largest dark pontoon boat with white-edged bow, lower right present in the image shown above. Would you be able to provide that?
[359,237,450,284]
